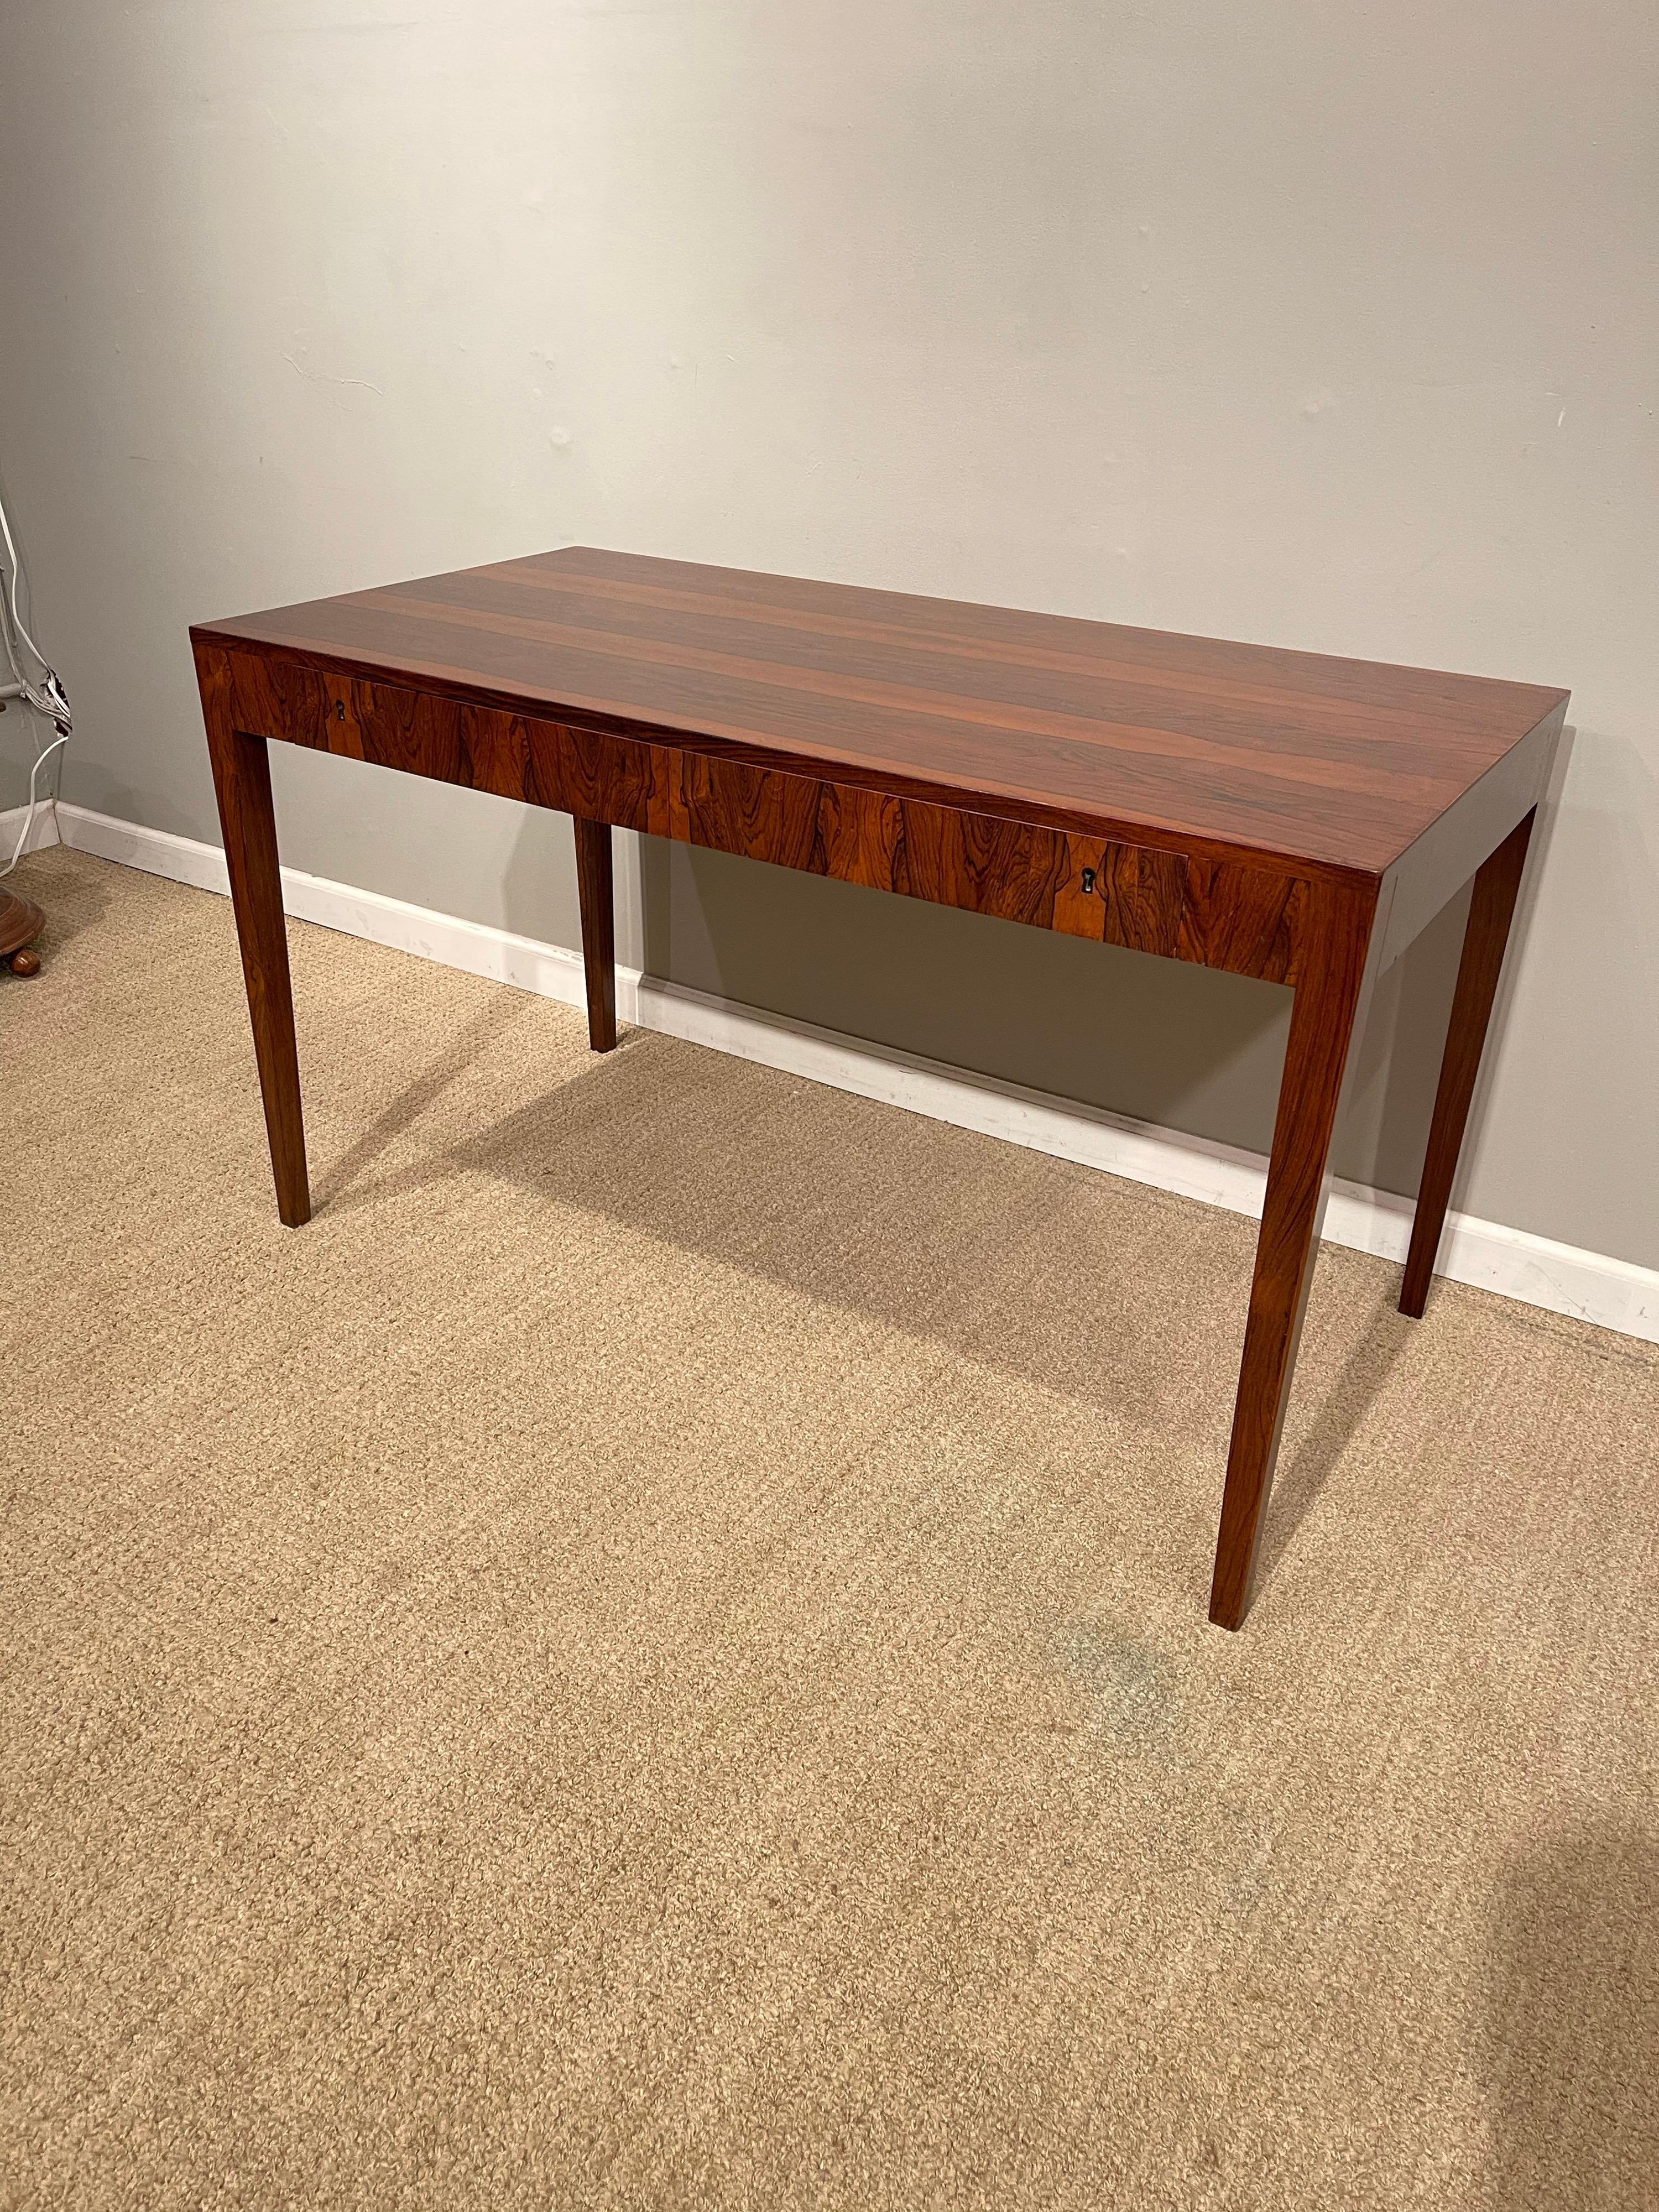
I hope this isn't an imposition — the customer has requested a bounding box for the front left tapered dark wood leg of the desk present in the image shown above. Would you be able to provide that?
[208,721,312,1230]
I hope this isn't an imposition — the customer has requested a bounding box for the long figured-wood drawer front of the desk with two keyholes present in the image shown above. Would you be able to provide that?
[197,646,1305,982]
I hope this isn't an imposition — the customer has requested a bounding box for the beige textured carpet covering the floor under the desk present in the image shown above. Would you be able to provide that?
[0,852,1659,2212]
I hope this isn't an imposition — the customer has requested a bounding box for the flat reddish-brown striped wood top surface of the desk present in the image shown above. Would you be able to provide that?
[192,546,1566,874]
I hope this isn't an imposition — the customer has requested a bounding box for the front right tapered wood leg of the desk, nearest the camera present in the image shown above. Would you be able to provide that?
[1210,891,1374,1628]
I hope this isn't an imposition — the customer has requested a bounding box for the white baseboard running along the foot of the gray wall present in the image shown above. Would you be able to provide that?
[39,805,1659,1343]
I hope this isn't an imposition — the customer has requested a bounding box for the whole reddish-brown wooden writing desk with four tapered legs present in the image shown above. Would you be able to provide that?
[190,546,1568,1628]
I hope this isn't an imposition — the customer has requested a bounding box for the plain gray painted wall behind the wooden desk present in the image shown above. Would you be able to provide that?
[0,0,1659,1265]
